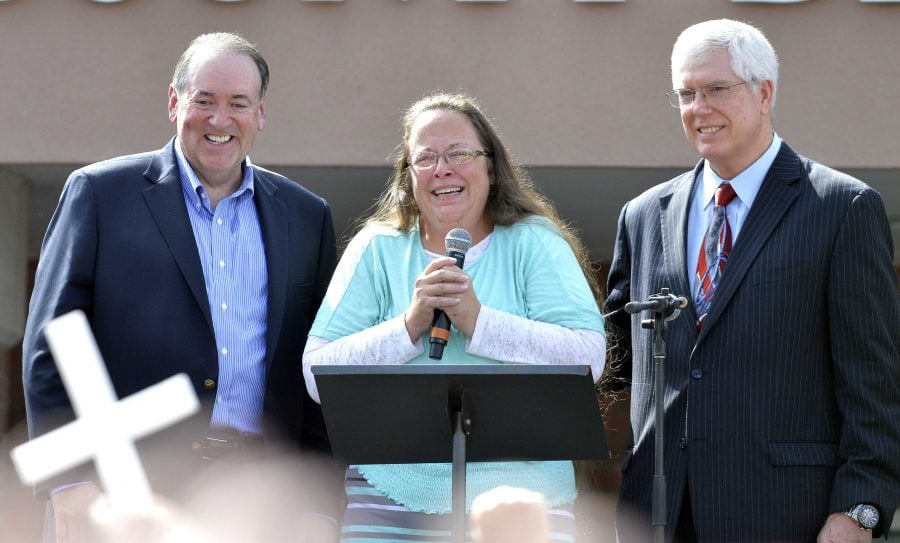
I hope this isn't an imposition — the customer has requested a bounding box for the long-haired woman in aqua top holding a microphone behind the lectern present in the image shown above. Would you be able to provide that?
[303,93,606,543]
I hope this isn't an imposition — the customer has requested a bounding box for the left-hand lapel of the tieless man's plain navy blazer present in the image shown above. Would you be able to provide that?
[144,139,213,330]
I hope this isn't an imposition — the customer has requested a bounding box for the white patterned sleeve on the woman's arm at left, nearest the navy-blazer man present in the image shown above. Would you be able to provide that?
[303,314,425,403]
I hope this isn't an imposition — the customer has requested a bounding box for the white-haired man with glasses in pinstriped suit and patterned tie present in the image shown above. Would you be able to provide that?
[606,20,900,542]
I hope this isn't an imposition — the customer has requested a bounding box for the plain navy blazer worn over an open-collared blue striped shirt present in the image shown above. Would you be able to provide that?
[23,139,336,506]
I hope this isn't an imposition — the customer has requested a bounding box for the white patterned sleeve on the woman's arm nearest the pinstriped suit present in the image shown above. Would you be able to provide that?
[466,306,606,383]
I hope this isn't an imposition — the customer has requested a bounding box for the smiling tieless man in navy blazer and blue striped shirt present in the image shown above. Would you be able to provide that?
[23,33,339,540]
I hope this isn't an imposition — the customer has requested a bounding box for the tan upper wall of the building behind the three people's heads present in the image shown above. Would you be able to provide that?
[0,0,900,168]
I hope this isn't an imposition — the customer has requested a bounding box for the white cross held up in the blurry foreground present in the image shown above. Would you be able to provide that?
[11,311,200,511]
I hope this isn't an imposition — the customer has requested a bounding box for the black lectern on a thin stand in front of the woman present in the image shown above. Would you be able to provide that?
[312,364,609,543]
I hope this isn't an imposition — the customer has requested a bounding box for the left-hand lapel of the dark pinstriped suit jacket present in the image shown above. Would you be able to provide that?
[653,162,703,328]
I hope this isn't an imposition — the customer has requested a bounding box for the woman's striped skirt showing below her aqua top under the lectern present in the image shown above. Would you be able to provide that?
[341,466,575,543]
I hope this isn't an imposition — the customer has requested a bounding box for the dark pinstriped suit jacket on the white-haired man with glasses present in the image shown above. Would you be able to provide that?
[606,144,900,542]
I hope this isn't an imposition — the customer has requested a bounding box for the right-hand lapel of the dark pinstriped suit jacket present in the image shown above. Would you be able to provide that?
[697,143,803,343]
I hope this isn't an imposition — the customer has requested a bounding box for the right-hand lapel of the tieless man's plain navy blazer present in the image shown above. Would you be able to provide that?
[253,168,288,374]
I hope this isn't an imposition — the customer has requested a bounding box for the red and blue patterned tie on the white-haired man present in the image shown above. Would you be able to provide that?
[694,183,735,330]
